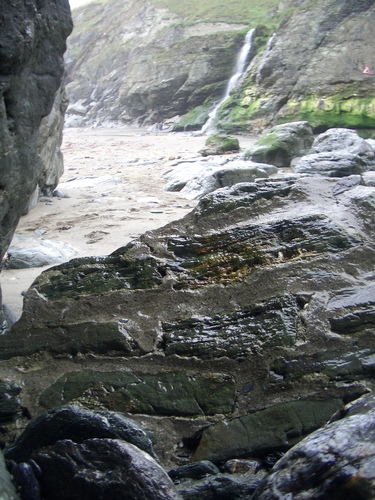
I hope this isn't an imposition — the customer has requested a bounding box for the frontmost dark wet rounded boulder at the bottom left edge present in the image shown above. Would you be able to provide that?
[32,438,181,500]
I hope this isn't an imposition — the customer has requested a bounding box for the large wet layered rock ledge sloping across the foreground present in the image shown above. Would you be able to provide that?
[0,170,375,463]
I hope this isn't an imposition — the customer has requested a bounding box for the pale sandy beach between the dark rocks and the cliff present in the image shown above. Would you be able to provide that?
[1,128,254,316]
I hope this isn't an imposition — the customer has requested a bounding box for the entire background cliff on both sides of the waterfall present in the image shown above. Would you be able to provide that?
[67,0,375,132]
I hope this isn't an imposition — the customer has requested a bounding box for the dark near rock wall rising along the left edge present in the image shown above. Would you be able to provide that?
[0,0,72,306]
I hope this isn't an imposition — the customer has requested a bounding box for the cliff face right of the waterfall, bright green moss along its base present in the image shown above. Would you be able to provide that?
[221,0,375,135]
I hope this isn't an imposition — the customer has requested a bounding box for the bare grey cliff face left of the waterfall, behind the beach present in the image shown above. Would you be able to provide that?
[67,0,254,125]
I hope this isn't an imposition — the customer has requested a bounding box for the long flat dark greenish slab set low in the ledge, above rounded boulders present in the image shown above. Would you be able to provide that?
[40,370,235,417]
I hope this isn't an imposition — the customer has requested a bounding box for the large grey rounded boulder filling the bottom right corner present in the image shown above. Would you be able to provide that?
[252,396,375,500]
